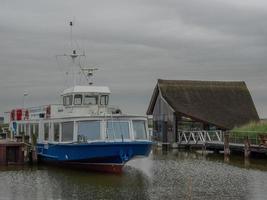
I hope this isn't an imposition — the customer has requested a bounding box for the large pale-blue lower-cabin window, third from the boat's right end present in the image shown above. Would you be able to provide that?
[78,121,101,141]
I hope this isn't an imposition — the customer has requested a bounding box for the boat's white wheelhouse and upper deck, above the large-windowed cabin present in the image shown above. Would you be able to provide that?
[22,86,121,119]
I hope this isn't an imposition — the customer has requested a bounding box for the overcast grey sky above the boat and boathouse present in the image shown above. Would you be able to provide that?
[0,0,267,117]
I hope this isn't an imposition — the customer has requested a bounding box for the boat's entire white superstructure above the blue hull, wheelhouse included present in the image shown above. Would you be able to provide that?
[7,86,149,143]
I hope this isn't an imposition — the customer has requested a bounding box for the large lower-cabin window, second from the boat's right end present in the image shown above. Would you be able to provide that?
[107,121,130,139]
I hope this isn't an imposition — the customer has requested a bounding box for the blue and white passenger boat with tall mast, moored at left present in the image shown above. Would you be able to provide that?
[6,22,152,173]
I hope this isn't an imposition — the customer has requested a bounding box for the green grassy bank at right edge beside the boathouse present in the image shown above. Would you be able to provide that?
[231,122,267,137]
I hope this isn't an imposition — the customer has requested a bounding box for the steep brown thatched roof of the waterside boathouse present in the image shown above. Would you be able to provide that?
[147,79,259,129]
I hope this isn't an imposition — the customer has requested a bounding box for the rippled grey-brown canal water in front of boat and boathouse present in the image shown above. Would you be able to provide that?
[0,149,267,200]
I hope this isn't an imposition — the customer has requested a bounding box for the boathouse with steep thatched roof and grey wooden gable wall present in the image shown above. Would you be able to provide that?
[147,79,259,147]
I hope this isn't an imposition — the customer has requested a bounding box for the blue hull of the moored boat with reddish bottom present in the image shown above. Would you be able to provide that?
[37,141,152,172]
